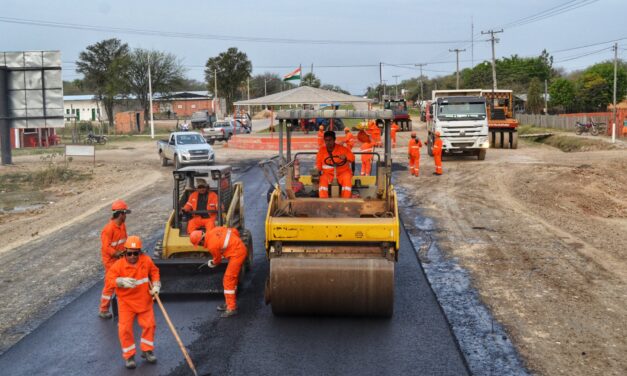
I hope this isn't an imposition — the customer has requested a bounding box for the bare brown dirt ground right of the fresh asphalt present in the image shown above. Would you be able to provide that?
[397,128,627,376]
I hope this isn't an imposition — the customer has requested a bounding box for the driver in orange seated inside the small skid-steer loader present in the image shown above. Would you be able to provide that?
[182,179,218,234]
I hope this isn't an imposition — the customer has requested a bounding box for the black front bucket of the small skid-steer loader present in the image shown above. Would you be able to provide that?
[153,258,227,296]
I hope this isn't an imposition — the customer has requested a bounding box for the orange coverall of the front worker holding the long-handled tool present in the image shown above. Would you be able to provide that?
[106,254,159,359]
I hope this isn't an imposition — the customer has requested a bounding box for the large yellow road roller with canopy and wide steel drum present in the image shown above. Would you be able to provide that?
[260,110,400,317]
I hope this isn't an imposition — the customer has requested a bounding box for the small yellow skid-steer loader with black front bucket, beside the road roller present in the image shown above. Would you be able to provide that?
[152,165,253,295]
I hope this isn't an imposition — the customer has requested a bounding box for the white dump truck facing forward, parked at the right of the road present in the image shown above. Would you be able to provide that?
[427,90,490,160]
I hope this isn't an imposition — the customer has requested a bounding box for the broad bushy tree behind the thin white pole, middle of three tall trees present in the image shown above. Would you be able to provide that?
[126,48,185,128]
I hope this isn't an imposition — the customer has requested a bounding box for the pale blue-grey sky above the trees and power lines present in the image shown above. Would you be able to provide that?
[0,0,627,95]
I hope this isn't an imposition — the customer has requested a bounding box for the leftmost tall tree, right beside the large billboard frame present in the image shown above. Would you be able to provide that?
[76,38,130,125]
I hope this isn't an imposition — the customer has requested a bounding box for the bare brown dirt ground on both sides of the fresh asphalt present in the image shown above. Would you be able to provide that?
[0,127,627,375]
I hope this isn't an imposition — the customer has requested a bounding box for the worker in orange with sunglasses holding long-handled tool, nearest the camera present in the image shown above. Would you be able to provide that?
[106,236,161,368]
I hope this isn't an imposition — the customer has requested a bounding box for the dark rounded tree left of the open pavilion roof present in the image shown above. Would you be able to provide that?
[205,47,253,111]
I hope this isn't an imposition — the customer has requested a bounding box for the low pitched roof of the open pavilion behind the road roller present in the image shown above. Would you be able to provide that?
[235,86,372,106]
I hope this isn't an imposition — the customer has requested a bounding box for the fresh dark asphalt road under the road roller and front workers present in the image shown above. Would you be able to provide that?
[0,161,468,375]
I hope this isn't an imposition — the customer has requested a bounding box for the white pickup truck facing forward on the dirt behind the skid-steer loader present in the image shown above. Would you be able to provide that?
[157,132,215,170]
